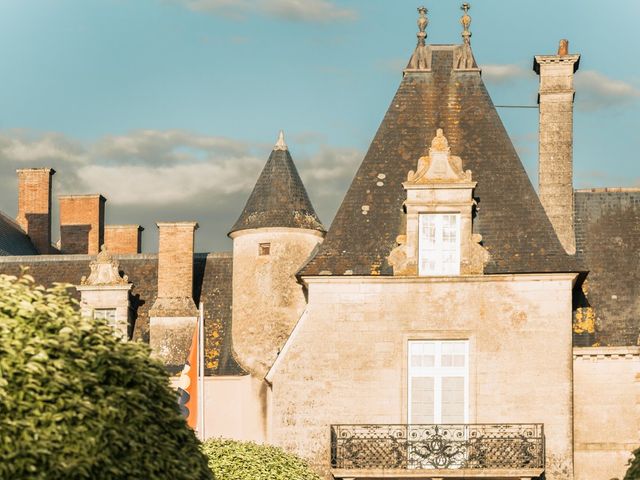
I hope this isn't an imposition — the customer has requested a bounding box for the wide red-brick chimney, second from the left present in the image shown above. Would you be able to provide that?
[58,194,107,255]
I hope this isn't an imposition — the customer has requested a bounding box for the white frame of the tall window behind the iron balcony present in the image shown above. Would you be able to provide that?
[407,340,469,425]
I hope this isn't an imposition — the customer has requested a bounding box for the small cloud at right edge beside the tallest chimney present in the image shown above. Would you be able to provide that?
[575,70,640,110]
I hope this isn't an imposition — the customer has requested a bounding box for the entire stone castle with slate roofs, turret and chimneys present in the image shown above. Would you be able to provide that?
[0,8,640,480]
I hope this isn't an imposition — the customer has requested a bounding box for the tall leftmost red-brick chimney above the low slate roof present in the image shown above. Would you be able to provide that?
[16,168,56,254]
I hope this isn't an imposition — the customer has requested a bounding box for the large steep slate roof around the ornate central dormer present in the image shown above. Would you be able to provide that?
[300,45,580,275]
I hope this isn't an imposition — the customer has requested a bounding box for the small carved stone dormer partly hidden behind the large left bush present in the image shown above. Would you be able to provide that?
[76,245,133,340]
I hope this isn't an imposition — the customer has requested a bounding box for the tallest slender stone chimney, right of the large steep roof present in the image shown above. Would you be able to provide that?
[533,40,580,254]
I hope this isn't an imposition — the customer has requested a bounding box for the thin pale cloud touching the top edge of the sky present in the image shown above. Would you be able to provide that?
[172,0,356,23]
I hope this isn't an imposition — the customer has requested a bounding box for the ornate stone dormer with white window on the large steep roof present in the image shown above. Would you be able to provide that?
[388,128,489,276]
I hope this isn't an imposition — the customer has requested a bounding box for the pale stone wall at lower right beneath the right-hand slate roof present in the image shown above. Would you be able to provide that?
[573,347,640,480]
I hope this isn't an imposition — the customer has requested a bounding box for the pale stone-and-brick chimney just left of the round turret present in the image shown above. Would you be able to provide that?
[149,222,198,367]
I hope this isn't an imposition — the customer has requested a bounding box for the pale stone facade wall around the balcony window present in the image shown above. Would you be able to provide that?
[269,274,573,480]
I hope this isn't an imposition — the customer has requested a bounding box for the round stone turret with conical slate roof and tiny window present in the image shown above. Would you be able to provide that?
[229,132,325,377]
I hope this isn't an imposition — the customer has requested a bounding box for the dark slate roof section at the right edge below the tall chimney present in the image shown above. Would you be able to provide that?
[574,188,640,346]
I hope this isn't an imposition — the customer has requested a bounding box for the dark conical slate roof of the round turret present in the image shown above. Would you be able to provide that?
[229,132,324,233]
